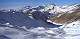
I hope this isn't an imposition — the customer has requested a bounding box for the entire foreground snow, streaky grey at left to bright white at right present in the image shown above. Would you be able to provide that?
[0,21,80,39]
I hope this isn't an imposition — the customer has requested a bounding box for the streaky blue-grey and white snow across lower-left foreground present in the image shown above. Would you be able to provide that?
[0,27,64,39]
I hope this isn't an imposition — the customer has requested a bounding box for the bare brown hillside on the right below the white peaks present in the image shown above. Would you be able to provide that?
[50,8,80,24]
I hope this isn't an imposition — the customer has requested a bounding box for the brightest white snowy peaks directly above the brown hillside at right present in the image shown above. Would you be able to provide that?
[45,4,79,13]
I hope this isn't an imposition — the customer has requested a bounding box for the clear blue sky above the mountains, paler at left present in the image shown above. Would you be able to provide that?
[0,0,80,9]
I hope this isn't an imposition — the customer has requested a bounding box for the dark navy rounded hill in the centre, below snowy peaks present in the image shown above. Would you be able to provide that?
[32,11,49,21]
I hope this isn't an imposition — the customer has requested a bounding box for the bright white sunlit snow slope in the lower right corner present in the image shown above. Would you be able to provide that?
[63,21,80,39]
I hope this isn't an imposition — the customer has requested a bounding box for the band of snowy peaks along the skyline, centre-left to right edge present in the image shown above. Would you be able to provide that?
[19,4,79,14]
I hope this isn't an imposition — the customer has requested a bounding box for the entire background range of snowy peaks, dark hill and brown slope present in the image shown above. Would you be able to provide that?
[0,4,80,24]
